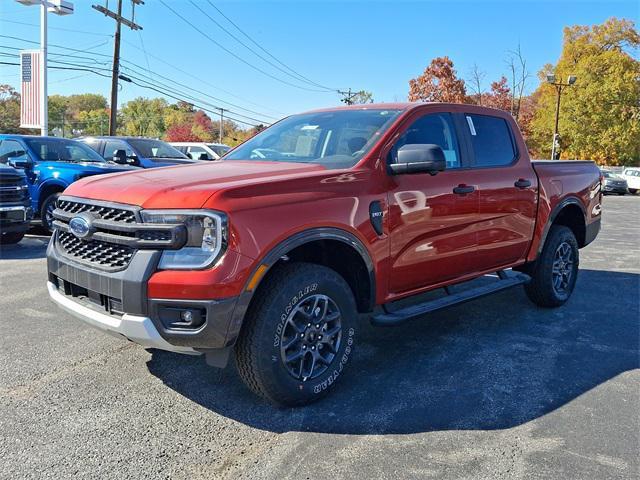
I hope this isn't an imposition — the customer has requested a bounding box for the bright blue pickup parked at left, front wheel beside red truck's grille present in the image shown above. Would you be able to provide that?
[0,135,133,232]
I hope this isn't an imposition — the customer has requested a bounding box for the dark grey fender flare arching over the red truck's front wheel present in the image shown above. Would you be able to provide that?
[226,227,376,345]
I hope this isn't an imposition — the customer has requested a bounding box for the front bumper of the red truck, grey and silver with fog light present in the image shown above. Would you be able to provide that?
[47,233,238,353]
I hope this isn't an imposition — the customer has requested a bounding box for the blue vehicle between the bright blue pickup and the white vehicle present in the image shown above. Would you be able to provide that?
[78,137,193,168]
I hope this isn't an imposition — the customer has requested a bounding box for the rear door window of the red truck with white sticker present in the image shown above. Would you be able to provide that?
[465,115,516,167]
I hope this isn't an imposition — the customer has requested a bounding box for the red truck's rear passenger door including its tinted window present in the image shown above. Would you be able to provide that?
[464,113,538,271]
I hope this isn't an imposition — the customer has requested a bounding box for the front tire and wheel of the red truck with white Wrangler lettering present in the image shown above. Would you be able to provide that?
[235,263,358,406]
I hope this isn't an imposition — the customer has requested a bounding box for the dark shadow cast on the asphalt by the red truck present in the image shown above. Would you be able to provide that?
[148,270,640,434]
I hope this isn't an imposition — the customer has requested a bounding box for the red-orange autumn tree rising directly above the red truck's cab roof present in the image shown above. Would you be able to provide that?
[409,57,467,103]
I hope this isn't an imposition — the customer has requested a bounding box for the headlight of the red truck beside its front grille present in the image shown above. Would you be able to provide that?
[141,210,227,270]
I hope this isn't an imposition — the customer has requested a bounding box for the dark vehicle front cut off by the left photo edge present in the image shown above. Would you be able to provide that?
[0,163,33,245]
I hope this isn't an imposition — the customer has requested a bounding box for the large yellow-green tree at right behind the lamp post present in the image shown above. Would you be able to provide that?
[530,18,640,165]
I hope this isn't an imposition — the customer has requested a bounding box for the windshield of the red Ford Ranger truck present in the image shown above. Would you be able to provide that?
[224,108,400,168]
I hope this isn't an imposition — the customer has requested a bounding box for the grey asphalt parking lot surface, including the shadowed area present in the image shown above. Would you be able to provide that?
[0,193,640,479]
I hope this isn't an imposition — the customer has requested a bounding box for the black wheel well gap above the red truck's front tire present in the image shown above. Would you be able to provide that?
[261,240,374,312]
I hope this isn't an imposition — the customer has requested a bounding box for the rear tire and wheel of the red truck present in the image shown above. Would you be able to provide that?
[524,225,580,308]
